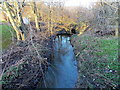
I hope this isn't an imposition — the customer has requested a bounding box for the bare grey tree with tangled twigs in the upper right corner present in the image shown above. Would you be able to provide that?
[93,0,119,36]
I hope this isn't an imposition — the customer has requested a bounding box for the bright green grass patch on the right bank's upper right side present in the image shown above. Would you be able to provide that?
[96,38,119,70]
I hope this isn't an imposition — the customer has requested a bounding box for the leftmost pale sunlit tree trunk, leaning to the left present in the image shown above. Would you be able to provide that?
[4,2,21,40]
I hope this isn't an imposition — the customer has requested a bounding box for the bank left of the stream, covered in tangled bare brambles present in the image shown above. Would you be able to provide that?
[0,32,52,90]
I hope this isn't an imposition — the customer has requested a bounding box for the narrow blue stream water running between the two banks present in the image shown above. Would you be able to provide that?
[38,36,78,88]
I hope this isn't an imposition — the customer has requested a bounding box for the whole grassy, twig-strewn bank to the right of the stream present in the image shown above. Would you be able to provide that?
[71,34,119,88]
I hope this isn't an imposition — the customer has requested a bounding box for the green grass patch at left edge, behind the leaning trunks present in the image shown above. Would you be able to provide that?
[0,25,15,50]
